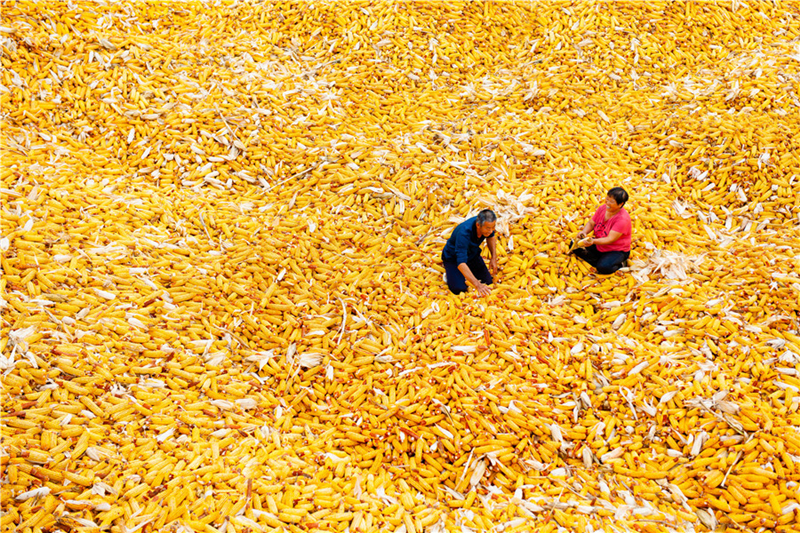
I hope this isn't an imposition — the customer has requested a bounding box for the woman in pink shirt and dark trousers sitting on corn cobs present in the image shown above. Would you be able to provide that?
[571,187,631,274]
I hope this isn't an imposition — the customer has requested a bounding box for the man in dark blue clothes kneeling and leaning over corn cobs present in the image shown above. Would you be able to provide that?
[442,209,497,296]
